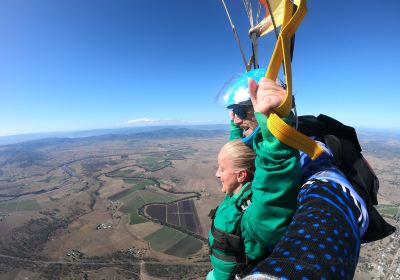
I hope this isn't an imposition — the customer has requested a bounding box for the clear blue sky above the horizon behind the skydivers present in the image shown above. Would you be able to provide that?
[0,0,400,136]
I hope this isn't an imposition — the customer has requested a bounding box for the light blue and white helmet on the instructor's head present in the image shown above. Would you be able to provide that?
[217,68,266,109]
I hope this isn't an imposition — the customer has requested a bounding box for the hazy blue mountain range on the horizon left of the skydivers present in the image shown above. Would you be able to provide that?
[0,124,229,146]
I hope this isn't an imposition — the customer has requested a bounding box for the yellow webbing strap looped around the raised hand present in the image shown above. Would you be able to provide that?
[265,0,323,160]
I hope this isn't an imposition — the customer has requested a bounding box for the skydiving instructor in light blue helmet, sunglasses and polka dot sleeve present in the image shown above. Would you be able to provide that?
[223,69,393,279]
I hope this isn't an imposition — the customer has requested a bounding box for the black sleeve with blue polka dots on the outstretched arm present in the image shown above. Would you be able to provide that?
[241,179,360,280]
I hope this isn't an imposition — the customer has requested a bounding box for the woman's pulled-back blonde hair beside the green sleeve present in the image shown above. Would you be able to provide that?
[221,139,256,178]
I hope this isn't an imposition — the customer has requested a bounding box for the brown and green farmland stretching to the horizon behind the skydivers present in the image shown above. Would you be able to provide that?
[0,128,400,279]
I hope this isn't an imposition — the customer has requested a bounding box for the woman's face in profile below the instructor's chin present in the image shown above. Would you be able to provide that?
[215,150,242,194]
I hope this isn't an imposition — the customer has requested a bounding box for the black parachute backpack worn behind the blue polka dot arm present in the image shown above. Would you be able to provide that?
[298,114,396,243]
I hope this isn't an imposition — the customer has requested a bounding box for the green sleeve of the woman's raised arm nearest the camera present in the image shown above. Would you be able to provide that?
[241,113,301,259]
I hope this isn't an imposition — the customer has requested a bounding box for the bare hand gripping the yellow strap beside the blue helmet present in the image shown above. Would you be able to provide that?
[249,78,286,116]
